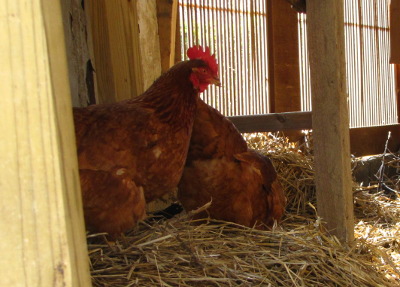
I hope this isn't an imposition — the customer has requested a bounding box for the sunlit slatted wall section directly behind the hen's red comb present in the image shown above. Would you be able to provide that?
[179,0,269,116]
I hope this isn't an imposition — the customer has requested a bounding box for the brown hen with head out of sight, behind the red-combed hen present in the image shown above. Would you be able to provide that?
[178,100,286,228]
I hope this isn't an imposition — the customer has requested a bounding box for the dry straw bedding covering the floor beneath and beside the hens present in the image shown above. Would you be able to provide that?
[88,134,400,287]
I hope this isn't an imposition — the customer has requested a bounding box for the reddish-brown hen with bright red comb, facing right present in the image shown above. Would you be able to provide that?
[74,47,219,235]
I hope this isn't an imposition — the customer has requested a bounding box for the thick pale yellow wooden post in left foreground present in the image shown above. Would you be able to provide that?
[0,0,91,287]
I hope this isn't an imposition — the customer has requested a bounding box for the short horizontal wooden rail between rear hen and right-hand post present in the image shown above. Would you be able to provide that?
[228,112,312,133]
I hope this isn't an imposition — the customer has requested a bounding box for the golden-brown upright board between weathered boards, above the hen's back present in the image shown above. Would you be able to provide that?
[85,0,143,103]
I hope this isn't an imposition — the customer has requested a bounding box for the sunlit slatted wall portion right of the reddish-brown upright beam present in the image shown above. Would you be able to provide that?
[299,0,398,127]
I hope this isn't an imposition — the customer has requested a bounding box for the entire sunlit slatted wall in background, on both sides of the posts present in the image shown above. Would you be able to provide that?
[179,0,398,127]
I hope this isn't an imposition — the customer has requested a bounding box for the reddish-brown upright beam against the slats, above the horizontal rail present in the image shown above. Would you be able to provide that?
[268,0,301,113]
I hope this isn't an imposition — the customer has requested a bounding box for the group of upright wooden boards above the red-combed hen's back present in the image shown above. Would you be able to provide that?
[61,0,161,107]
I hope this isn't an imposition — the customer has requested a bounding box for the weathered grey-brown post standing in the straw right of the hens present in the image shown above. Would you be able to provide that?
[307,0,354,242]
